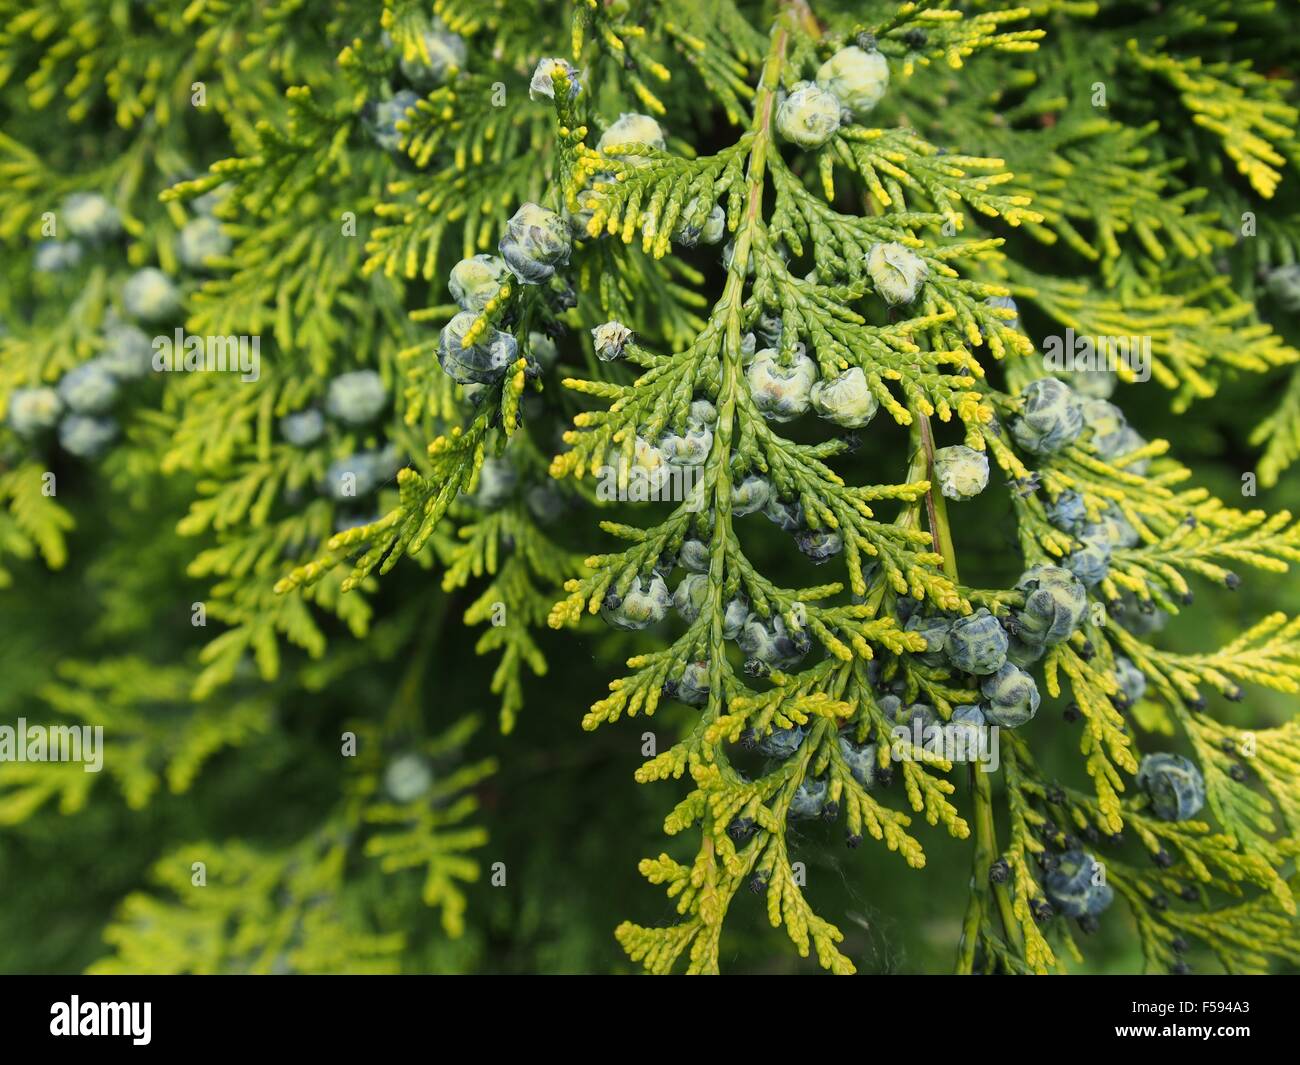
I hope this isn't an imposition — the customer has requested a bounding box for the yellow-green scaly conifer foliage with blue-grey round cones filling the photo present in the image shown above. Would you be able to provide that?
[0,0,1300,974]
